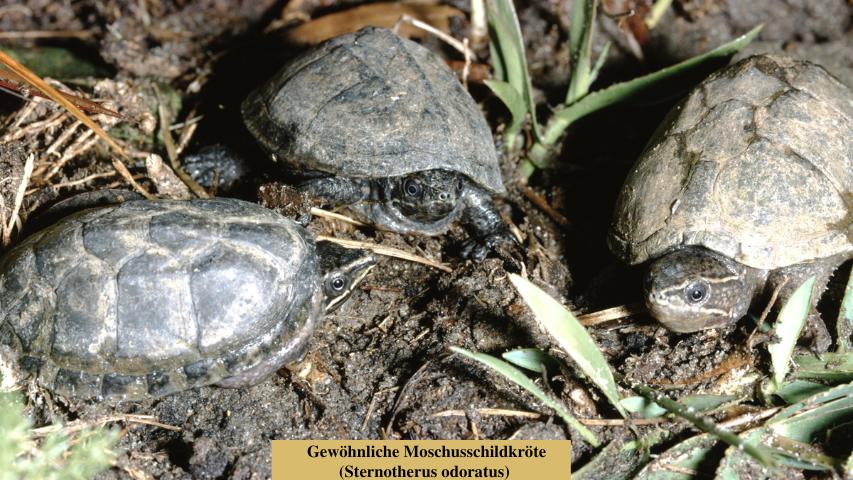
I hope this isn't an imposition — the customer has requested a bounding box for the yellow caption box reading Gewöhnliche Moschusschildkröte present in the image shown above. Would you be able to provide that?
[272,440,572,480]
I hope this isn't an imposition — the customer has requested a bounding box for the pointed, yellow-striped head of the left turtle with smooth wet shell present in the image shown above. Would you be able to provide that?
[317,241,376,313]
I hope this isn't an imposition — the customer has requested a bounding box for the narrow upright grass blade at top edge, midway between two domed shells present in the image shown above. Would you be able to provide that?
[566,0,598,105]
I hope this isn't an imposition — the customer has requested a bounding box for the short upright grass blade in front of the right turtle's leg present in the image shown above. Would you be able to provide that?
[767,276,815,393]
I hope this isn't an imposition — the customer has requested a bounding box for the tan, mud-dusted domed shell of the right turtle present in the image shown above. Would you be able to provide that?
[609,56,853,269]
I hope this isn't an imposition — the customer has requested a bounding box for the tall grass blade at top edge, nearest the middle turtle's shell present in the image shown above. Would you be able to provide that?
[486,0,540,139]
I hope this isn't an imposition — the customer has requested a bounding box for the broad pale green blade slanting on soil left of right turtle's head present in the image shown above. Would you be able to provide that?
[509,273,628,417]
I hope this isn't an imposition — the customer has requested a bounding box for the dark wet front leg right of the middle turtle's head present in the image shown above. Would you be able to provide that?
[461,184,521,262]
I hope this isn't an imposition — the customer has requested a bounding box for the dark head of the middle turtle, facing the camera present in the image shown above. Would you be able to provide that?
[390,170,464,222]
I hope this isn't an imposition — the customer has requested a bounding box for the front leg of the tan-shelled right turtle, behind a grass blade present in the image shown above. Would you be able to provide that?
[767,259,837,353]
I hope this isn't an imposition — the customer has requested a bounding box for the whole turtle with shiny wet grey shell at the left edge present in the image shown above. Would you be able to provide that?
[0,198,375,400]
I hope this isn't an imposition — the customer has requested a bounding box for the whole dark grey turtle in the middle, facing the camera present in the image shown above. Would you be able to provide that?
[241,27,517,260]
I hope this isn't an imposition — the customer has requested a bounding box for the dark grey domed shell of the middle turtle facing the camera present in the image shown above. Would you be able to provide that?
[242,27,505,193]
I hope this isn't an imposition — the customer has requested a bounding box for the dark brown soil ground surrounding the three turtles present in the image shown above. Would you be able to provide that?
[0,0,853,479]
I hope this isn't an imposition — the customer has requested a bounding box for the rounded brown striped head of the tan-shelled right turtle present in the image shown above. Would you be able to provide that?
[644,247,756,332]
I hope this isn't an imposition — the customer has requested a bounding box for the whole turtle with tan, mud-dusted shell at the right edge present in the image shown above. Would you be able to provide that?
[608,55,853,350]
